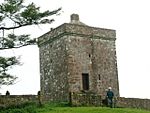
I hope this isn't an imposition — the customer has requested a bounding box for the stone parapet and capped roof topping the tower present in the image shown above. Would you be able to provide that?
[38,14,116,46]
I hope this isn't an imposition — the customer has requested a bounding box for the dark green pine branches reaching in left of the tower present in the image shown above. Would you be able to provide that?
[0,0,61,86]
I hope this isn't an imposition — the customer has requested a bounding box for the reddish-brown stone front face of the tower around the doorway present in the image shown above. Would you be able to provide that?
[65,35,119,98]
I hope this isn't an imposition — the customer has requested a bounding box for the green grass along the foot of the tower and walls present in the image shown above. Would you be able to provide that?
[0,104,150,113]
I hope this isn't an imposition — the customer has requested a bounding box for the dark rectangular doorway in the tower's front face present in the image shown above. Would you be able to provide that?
[82,73,89,90]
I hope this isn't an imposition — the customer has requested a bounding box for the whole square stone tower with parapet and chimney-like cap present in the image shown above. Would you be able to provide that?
[38,14,119,101]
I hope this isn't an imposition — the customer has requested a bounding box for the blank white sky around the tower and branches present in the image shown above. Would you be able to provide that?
[0,0,150,99]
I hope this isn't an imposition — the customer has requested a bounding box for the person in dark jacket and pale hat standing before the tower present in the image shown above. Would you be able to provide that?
[107,87,114,108]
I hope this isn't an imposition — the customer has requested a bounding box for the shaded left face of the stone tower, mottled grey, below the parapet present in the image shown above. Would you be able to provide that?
[40,36,69,101]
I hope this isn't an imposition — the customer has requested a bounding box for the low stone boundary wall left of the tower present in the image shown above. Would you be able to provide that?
[0,95,38,107]
